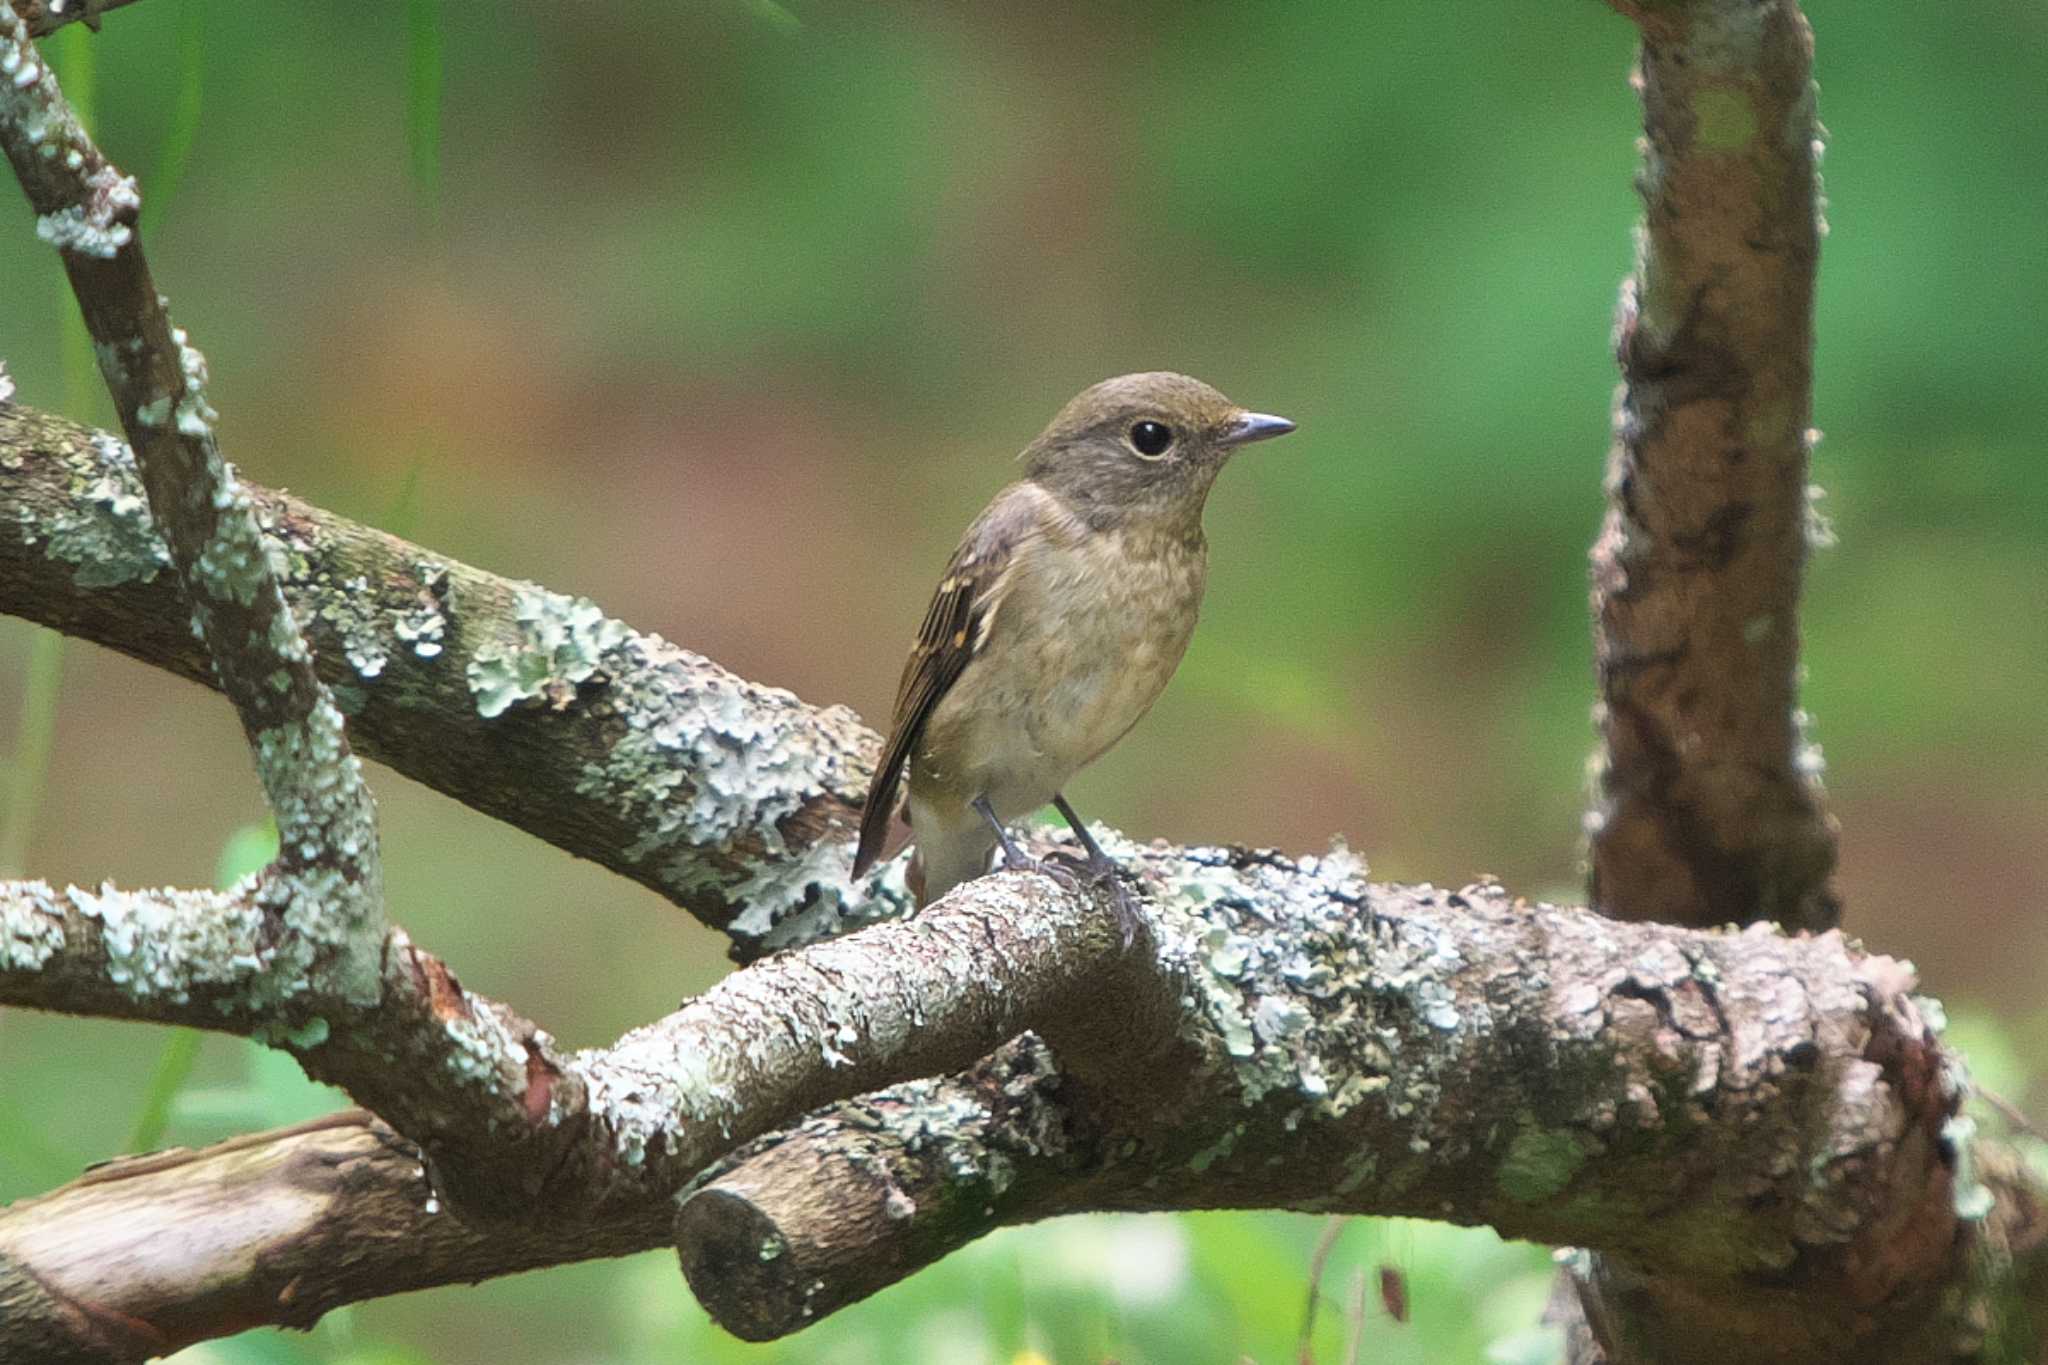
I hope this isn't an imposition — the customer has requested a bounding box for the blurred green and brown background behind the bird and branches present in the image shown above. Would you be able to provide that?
[0,0,2048,1365]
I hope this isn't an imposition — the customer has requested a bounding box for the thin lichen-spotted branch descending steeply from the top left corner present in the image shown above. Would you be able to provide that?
[0,6,383,1005]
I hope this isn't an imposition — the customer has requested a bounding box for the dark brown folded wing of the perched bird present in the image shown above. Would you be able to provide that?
[854,483,1042,876]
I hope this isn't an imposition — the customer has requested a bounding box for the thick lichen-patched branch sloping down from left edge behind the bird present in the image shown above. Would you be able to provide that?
[0,403,907,960]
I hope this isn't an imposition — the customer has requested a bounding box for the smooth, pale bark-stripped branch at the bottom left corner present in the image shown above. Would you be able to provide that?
[0,1109,668,1365]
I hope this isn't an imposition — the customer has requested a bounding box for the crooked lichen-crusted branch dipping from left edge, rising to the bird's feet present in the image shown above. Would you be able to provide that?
[0,878,1122,1222]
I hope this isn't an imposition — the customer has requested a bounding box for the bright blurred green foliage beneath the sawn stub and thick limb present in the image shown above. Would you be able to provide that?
[614,1214,1561,1365]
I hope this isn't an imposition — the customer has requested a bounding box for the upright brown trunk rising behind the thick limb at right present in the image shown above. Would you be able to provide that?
[1587,0,1837,929]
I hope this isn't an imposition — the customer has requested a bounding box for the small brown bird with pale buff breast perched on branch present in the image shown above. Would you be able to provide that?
[854,372,1294,945]
